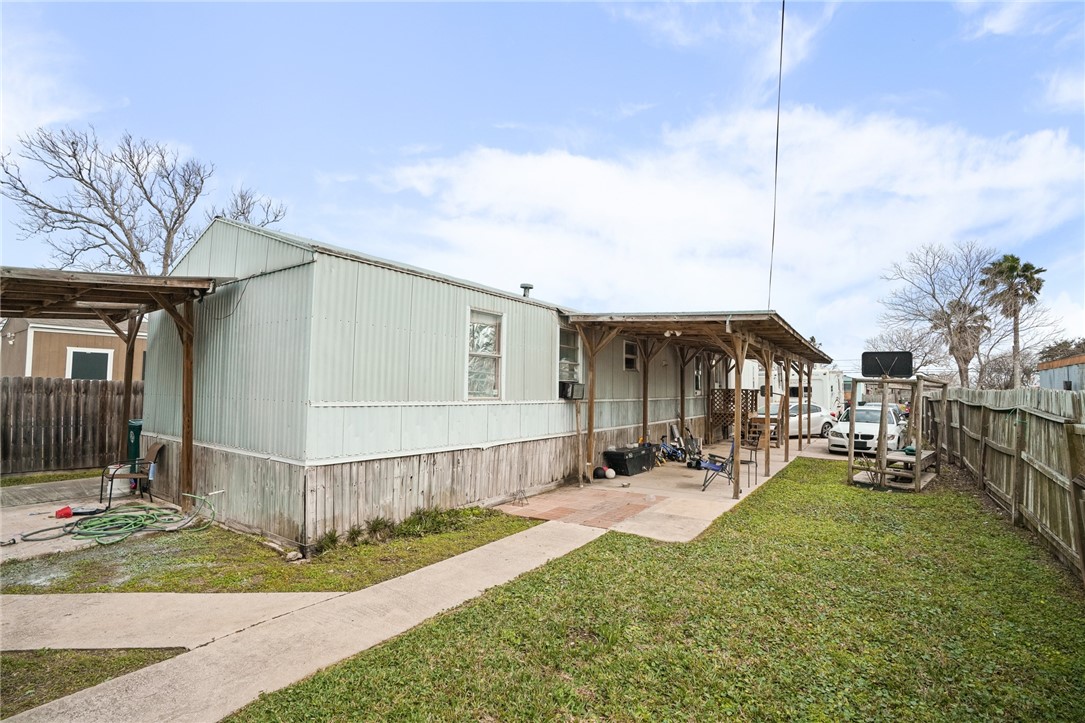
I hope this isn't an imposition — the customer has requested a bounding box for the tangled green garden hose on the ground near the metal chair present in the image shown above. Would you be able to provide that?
[21,493,217,545]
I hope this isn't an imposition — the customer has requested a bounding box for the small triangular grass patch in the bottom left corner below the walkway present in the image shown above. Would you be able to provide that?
[0,648,184,718]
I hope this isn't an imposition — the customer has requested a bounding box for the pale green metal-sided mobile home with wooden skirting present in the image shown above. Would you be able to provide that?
[143,218,821,543]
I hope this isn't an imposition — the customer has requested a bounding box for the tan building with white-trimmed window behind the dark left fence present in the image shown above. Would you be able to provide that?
[0,318,146,380]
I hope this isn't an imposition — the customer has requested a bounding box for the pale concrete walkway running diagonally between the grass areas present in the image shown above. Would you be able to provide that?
[3,522,605,723]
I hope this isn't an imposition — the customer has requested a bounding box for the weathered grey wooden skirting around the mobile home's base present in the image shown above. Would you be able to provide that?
[143,417,704,544]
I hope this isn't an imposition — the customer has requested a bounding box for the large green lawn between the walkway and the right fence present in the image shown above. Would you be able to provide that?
[231,459,1085,721]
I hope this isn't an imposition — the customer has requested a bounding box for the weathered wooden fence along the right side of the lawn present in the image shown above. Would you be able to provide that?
[927,388,1085,580]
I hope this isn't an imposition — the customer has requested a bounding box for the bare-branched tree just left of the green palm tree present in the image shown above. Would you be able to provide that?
[881,241,994,386]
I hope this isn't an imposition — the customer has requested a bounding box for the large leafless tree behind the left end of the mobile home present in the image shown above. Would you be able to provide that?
[0,127,286,275]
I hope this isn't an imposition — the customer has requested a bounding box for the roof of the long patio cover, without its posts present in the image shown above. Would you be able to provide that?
[566,310,832,364]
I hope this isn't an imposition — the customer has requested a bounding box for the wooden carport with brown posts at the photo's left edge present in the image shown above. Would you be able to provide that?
[0,266,220,505]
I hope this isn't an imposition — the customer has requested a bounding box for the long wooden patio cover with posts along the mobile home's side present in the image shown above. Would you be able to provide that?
[565,310,832,499]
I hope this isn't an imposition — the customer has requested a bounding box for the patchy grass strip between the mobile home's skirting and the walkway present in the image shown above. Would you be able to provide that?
[0,508,537,594]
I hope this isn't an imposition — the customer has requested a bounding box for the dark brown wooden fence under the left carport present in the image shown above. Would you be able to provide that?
[0,377,143,474]
